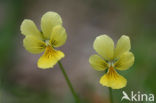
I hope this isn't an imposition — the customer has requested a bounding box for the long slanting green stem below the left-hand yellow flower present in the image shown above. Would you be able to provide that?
[58,61,80,103]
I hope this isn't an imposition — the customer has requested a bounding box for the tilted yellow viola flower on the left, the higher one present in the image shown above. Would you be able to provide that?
[21,12,67,69]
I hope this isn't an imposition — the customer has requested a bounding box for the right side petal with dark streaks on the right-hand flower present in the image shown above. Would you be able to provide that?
[114,52,134,70]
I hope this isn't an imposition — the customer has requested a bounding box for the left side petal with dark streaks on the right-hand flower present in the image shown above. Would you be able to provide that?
[89,55,108,71]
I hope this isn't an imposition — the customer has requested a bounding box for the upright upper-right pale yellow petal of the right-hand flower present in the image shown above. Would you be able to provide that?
[114,35,131,58]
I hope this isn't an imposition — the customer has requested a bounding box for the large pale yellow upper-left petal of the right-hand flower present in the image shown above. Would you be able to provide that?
[93,35,114,60]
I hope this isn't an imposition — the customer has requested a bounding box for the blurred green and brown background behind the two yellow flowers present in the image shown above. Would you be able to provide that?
[0,0,156,103]
